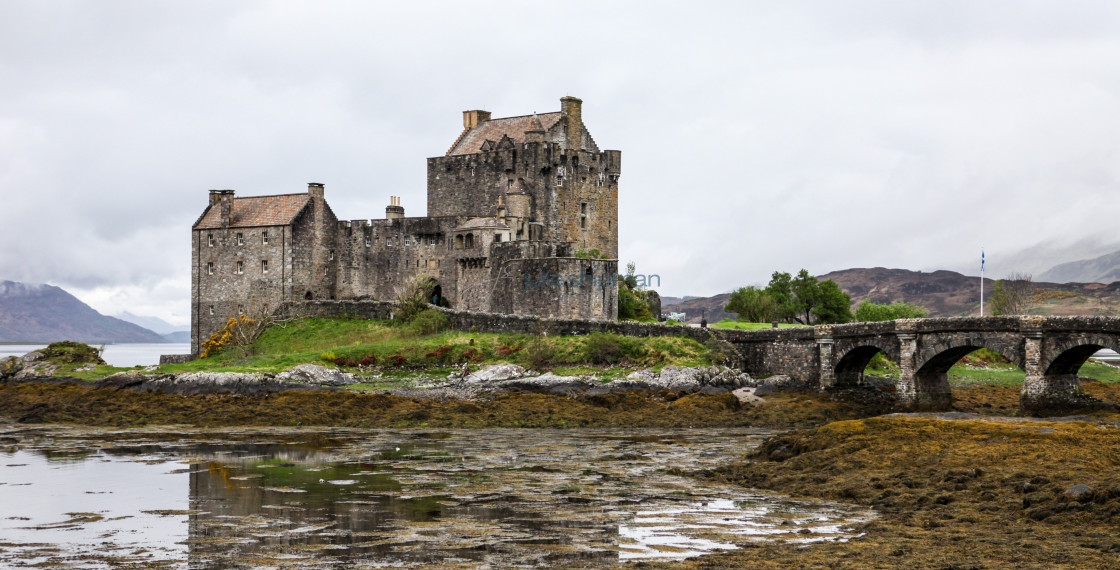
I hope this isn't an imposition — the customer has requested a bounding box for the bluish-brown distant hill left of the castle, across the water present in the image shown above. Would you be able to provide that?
[0,281,166,343]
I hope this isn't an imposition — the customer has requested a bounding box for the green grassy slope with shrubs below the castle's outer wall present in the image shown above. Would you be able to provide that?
[160,318,711,382]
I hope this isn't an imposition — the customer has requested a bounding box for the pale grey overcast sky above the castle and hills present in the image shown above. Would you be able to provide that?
[0,0,1120,324]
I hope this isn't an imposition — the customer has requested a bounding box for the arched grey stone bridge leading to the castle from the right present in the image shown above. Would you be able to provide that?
[719,317,1120,411]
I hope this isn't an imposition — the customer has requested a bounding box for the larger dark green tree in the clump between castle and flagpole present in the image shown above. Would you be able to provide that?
[766,269,851,325]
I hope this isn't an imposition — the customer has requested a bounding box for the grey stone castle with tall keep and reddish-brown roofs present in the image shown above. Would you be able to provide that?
[197,97,622,355]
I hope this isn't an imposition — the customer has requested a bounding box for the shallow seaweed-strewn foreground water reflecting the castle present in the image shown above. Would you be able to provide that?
[0,426,871,568]
